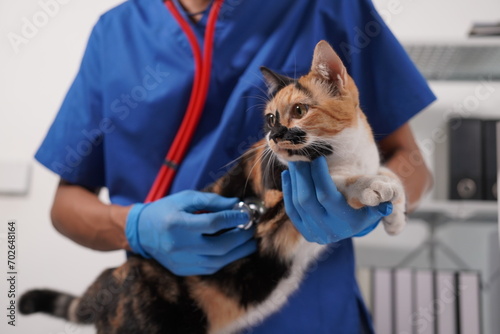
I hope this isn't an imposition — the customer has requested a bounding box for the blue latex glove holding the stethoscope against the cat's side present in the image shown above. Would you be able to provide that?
[125,191,257,276]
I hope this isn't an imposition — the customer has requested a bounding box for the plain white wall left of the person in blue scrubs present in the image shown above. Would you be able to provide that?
[0,0,124,334]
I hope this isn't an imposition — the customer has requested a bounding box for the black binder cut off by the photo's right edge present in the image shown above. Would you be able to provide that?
[482,120,497,200]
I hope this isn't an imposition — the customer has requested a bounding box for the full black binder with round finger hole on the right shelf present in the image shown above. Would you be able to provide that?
[448,118,483,200]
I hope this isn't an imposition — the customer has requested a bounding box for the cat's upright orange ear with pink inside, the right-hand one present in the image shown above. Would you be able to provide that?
[311,41,348,88]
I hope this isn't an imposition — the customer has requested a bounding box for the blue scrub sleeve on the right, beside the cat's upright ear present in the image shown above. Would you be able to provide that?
[336,0,436,140]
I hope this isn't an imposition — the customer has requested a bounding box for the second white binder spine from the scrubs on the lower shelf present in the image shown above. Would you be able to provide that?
[372,269,393,333]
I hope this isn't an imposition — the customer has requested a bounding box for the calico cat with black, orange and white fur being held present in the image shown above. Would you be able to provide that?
[20,41,406,334]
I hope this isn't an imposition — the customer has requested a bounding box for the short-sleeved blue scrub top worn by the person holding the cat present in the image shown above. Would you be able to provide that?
[36,0,435,334]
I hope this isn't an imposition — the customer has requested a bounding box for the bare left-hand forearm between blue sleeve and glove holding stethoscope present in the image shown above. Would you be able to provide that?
[51,182,130,251]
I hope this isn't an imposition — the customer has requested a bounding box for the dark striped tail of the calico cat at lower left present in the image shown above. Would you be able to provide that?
[19,290,94,324]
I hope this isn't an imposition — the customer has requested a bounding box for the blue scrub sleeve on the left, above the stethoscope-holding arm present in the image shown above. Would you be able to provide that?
[35,21,106,187]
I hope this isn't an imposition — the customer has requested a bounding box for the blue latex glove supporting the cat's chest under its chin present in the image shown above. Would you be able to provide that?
[281,157,392,244]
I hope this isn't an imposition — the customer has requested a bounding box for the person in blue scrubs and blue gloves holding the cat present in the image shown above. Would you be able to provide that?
[36,0,435,334]
